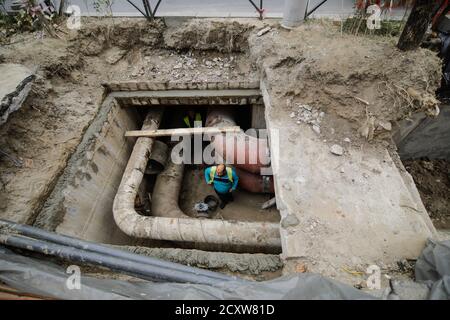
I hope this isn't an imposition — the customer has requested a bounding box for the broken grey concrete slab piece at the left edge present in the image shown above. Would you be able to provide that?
[0,63,35,125]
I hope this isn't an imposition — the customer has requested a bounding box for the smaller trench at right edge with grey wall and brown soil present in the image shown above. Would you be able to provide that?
[394,105,450,234]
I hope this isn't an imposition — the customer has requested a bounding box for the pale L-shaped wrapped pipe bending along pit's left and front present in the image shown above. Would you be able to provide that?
[113,109,281,248]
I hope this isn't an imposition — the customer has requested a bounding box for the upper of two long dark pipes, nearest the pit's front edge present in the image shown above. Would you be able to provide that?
[0,219,239,281]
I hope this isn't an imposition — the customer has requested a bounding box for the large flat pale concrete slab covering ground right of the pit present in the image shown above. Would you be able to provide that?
[261,83,436,284]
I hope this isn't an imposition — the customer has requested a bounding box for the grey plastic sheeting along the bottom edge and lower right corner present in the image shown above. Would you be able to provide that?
[0,241,450,300]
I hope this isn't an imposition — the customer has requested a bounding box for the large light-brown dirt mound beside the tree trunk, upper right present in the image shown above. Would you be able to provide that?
[250,22,441,140]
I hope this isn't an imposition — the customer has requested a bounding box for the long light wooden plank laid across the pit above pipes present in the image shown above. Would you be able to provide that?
[125,126,241,138]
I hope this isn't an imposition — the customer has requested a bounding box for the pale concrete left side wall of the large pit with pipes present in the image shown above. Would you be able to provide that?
[36,98,140,244]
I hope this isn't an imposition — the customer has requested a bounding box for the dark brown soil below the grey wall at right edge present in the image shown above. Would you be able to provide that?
[404,159,450,229]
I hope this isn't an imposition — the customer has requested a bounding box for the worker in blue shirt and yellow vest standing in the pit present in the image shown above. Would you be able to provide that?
[205,164,239,209]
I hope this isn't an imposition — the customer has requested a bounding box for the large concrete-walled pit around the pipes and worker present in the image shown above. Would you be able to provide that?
[35,85,283,280]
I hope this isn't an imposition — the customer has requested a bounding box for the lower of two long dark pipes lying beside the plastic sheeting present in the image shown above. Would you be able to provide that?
[0,235,230,285]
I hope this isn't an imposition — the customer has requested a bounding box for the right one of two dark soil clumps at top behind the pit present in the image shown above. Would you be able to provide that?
[164,19,254,52]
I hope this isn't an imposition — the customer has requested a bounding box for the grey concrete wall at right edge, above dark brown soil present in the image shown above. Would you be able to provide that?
[395,105,450,160]
